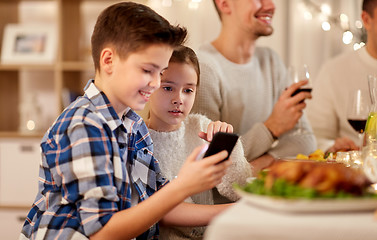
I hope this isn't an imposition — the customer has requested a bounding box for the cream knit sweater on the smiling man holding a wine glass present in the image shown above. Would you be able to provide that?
[192,43,316,161]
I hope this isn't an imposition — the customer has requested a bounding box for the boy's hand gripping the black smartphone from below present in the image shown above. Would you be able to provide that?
[173,145,231,196]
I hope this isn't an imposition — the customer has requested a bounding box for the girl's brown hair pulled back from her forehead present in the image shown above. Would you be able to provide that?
[169,46,200,85]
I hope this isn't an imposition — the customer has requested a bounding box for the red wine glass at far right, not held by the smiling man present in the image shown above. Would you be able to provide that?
[347,89,371,149]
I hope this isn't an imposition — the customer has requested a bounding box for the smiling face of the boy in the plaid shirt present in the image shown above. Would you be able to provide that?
[102,44,173,114]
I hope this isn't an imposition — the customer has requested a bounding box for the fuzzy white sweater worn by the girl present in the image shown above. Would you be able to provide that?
[149,114,251,239]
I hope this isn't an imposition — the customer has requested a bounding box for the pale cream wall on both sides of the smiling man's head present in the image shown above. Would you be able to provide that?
[147,0,362,78]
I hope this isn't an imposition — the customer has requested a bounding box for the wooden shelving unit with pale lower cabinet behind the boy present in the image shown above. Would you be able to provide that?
[0,0,128,210]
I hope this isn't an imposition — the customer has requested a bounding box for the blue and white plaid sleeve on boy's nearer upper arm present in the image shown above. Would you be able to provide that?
[49,117,119,236]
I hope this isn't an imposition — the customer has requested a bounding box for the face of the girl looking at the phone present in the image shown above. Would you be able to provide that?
[148,62,198,132]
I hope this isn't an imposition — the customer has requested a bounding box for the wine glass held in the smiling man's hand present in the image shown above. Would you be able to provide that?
[287,64,313,135]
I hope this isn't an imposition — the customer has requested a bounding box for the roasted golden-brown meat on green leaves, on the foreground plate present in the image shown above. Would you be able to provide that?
[241,161,377,198]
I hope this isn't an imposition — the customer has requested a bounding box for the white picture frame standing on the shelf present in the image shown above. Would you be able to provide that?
[1,24,57,65]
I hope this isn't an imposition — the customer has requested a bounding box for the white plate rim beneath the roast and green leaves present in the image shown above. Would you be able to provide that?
[235,188,377,213]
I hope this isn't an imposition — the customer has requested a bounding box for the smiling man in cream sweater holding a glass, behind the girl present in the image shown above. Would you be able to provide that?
[193,0,316,172]
